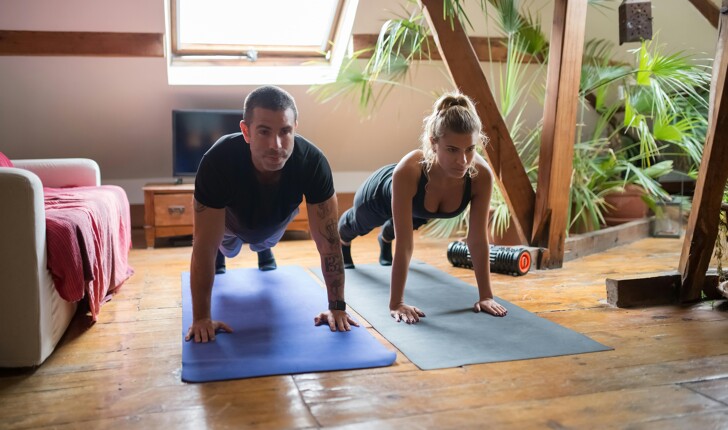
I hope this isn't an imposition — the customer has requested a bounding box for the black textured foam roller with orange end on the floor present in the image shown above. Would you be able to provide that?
[447,242,531,276]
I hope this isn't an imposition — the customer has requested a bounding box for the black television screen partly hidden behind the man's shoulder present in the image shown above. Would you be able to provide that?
[172,109,243,176]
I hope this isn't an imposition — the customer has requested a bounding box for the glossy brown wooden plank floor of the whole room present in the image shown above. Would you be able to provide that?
[0,235,728,430]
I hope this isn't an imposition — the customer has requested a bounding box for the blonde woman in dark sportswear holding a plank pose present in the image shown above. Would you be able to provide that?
[339,93,507,324]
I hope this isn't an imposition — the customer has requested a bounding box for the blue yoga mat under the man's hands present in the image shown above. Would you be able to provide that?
[182,266,396,382]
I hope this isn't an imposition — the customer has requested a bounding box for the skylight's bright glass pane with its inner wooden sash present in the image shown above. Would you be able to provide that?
[170,0,348,65]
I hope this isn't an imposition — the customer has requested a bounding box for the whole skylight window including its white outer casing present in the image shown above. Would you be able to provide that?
[165,0,359,85]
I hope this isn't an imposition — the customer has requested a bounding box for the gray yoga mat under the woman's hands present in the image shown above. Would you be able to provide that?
[311,261,612,370]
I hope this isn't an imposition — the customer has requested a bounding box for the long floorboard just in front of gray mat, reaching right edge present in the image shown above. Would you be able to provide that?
[299,354,728,425]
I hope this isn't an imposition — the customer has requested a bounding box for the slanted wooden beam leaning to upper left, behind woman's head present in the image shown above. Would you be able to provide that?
[420,0,535,244]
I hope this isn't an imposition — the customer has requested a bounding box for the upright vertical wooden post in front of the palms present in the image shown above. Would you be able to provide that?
[531,0,587,268]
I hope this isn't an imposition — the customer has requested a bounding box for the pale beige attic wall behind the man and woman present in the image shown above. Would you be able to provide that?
[0,0,718,203]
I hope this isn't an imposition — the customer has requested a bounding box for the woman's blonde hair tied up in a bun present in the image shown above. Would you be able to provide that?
[420,91,488,177]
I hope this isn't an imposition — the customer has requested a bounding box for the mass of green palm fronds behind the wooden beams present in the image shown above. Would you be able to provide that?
[312,0,709,241]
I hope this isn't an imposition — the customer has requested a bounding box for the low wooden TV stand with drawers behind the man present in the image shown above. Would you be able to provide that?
[143,184,308,248]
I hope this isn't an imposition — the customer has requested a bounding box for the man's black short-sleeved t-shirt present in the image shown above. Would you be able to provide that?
[195,133,334,243]
